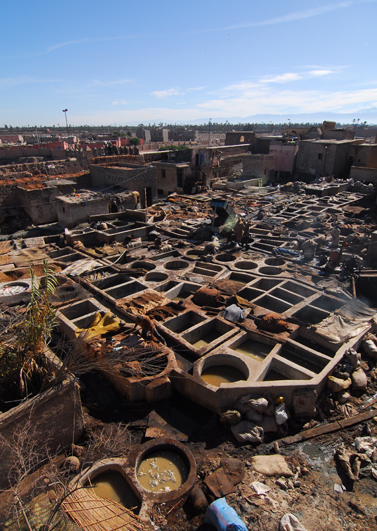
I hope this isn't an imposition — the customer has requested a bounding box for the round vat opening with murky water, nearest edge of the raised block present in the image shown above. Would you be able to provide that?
[197,354,249,387]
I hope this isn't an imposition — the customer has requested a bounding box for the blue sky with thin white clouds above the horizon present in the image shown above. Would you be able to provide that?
[0,0,377,126]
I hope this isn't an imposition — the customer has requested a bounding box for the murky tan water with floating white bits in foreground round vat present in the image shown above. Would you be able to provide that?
[137,450,187,492]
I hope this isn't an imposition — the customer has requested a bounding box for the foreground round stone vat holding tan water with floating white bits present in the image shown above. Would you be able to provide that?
[135,439,196,502]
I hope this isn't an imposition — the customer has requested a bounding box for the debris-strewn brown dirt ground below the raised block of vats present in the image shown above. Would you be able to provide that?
[73,361,377,531]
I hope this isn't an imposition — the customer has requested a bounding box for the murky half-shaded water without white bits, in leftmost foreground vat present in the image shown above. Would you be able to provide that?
[86,472,140,510]
